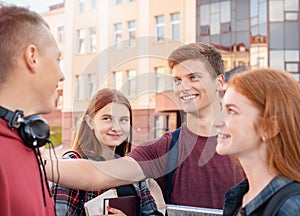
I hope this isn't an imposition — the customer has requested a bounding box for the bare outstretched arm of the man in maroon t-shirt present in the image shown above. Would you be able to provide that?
[46,156,145,191]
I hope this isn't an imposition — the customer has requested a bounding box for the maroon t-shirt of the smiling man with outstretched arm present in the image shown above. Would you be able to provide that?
[129,123,242,209]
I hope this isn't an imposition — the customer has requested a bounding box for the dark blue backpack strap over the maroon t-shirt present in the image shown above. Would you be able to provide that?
[164,128,180,204]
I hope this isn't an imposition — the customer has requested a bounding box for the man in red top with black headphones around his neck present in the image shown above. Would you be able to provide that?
[0,4,64,216]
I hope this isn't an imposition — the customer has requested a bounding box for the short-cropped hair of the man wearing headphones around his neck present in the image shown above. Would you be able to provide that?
[0,4,49,84]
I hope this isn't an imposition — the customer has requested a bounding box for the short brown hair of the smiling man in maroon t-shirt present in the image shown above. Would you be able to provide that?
[168,42,224,79]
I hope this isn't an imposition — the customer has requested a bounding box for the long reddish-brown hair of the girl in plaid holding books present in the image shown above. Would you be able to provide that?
[73,88,132,159]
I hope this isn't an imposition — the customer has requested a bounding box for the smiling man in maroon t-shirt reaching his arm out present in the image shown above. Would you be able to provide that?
[47,43,241,209]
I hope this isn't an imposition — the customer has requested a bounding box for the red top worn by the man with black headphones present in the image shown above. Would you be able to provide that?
[0,119,55,216]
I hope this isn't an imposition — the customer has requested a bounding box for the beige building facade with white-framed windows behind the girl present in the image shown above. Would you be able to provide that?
[42,0,196,147]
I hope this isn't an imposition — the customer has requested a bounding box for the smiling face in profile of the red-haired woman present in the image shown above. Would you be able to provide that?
[213,87,261,158]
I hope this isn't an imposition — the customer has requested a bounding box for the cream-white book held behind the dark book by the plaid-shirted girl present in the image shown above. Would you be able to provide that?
[84,189,118,216]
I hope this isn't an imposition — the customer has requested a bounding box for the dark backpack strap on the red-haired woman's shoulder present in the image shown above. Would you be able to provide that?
[263,182,300,216]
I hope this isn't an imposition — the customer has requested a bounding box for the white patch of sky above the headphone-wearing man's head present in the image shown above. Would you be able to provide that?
[0,0,63,13]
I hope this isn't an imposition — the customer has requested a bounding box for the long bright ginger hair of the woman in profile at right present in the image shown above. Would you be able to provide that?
[228,68,300,181]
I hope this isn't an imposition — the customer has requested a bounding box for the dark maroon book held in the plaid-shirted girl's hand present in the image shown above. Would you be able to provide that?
[103,196,139,216]
